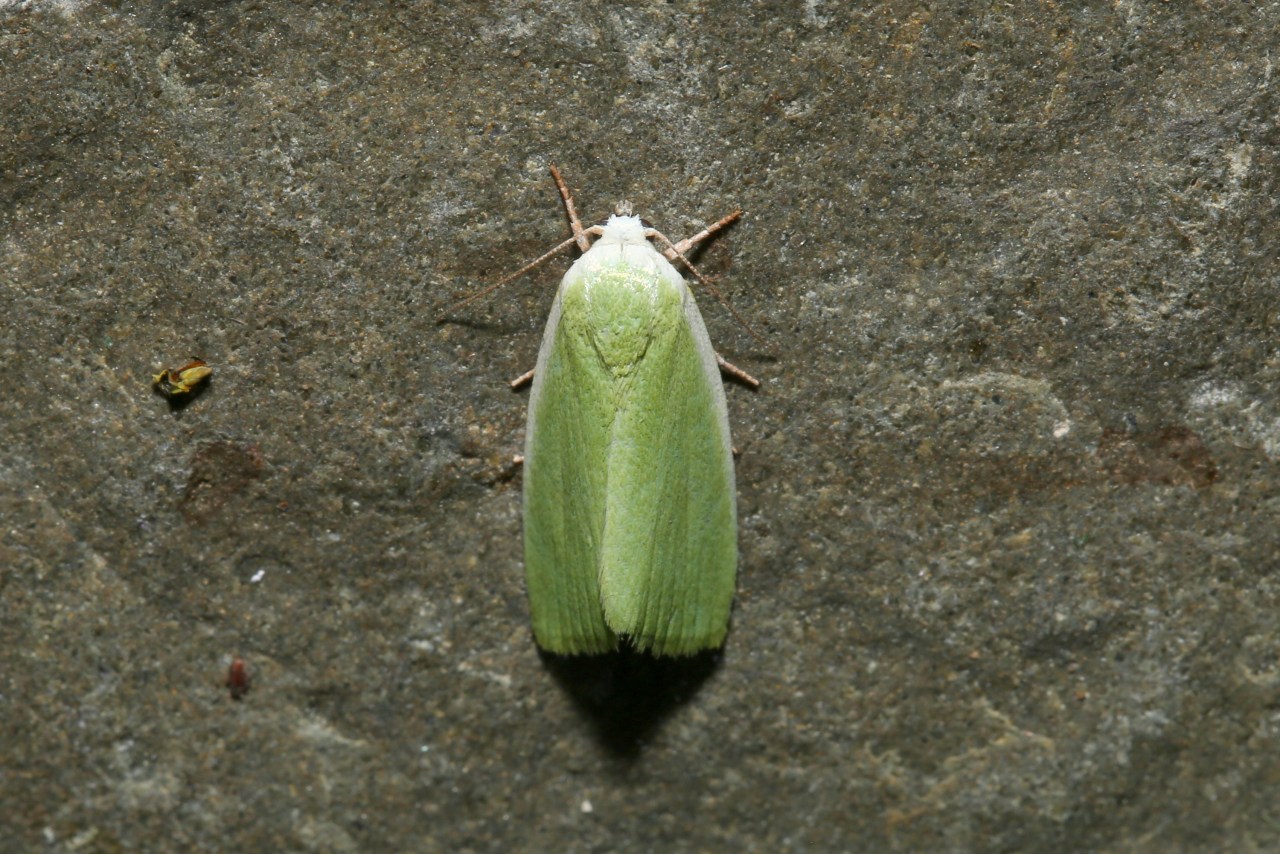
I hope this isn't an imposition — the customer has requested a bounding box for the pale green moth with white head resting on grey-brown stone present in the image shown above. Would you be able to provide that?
[495,166,756,656]
